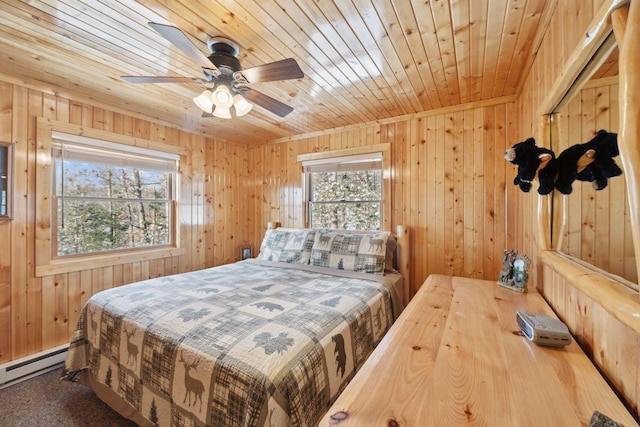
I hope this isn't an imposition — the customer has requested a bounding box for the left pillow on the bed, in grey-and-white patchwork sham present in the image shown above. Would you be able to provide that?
[257,229,315,264]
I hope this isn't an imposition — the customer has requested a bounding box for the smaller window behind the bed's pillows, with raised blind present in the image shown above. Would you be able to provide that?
[303,152,383,230]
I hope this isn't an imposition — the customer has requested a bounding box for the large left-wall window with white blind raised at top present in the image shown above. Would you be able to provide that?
[51,131,179,258]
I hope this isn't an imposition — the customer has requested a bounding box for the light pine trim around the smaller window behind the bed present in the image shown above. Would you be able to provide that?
[297,143,391,230]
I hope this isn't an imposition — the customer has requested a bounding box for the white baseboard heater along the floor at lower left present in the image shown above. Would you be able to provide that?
[0,344,69,390]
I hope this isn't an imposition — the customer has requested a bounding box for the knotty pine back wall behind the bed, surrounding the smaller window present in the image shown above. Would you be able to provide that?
[247,101,516,296]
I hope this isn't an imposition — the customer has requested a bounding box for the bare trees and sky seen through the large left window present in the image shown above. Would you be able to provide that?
[54,159,172,256]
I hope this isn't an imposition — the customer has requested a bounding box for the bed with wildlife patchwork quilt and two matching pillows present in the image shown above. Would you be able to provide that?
[63,228,408,426]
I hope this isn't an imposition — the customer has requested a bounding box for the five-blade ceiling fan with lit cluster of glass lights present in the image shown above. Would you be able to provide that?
[122,22,304,119]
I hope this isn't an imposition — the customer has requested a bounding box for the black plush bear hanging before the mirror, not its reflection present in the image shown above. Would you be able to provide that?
[504,138,556,195]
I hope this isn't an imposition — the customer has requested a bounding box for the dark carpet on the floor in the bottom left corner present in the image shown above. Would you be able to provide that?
[0,369,136,427]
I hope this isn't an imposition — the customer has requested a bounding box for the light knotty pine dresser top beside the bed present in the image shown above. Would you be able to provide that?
[320,275,637,427]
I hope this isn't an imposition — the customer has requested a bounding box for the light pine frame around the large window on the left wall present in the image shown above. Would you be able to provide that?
[35,117,188,277]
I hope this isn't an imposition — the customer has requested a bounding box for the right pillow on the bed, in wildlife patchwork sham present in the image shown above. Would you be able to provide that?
[311,231,389,274]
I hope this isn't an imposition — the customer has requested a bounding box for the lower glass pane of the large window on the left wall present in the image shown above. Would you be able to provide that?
[56,198,170,255]
